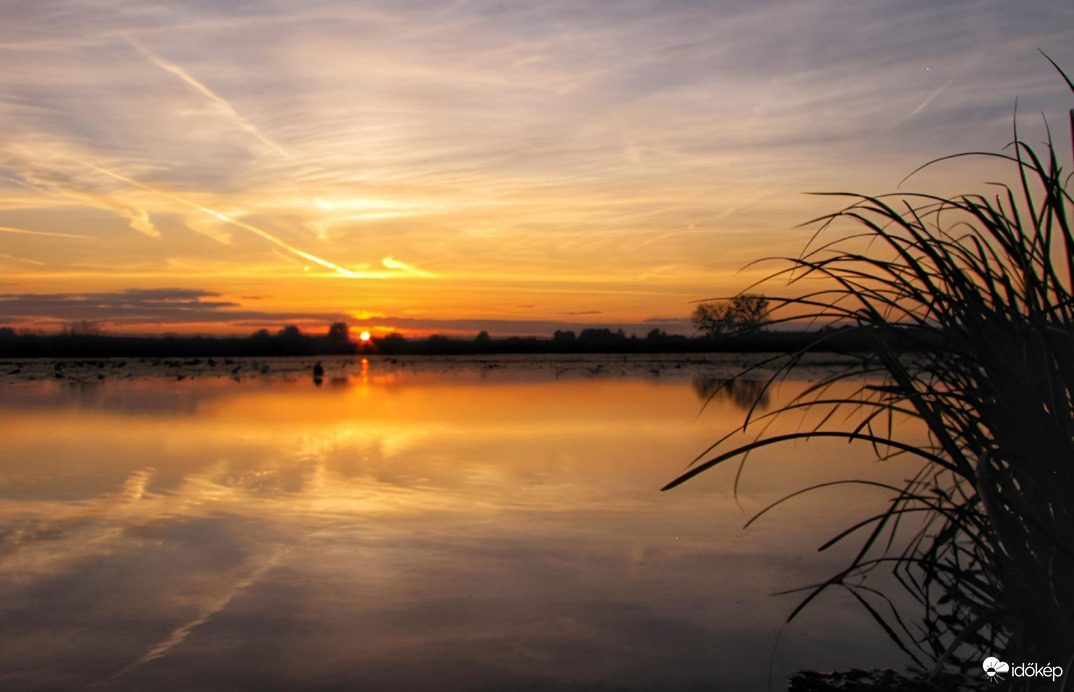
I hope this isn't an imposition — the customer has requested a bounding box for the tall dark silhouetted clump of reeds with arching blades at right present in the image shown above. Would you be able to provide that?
[666,62,1074,689]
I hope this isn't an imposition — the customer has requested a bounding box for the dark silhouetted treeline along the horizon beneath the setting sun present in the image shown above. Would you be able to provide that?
[0,323,893,358]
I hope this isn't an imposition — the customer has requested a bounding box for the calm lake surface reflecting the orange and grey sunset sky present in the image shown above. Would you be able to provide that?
[0,357,913,691]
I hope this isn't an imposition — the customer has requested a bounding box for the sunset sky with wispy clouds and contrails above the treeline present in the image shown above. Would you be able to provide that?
[0,0,1074,336]
